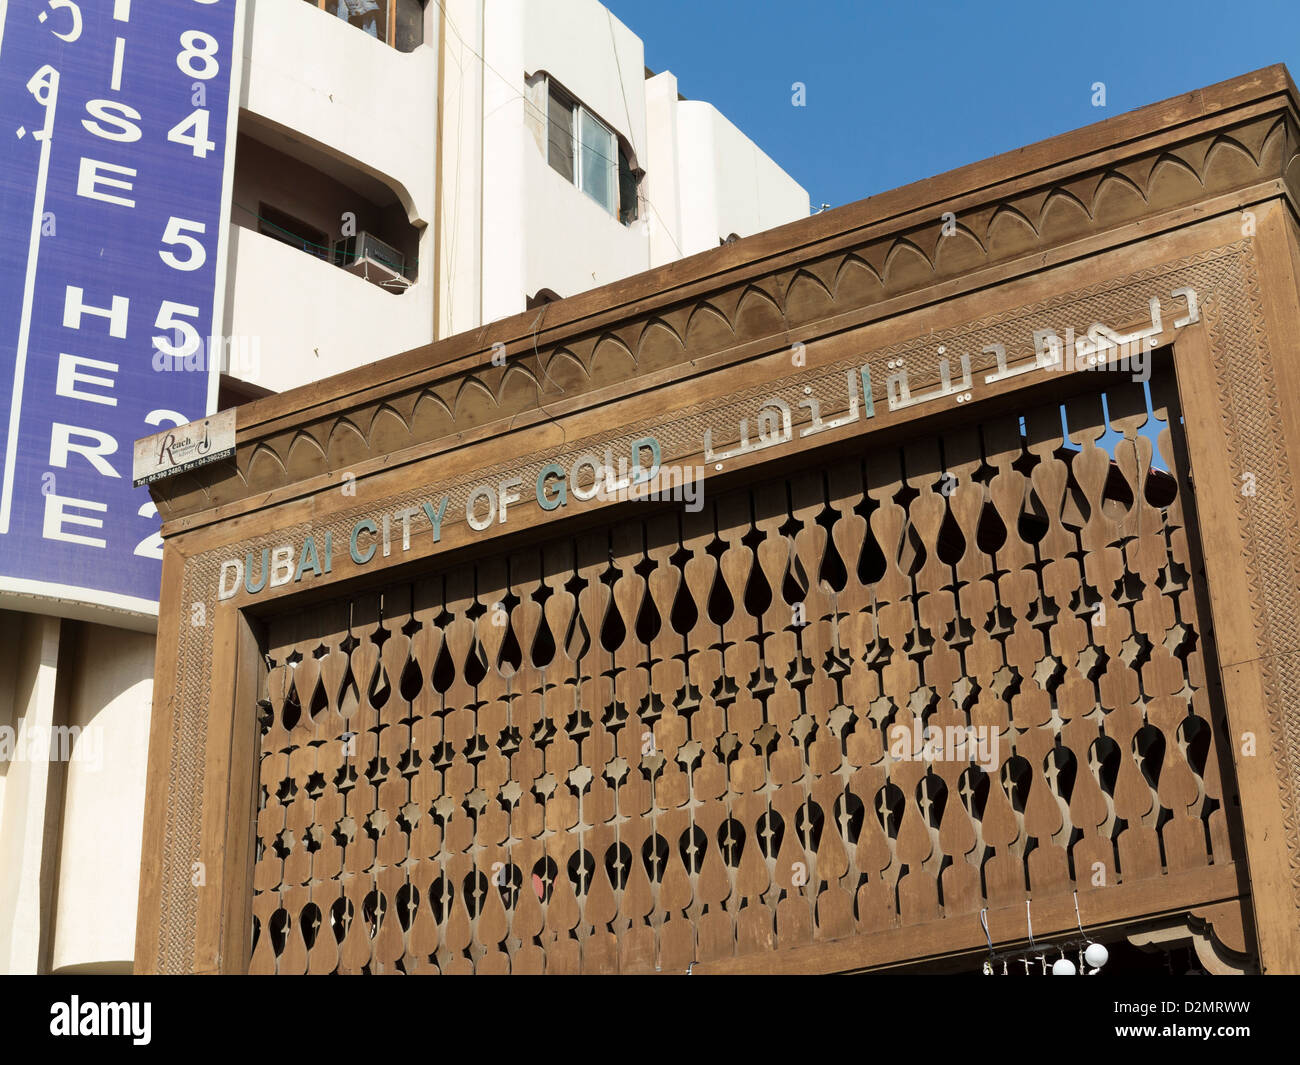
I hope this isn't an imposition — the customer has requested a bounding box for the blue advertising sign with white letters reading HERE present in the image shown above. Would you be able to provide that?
[0,0,242,614]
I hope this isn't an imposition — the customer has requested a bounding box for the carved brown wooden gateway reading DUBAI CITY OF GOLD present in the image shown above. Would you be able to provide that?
[135,68,1300,973]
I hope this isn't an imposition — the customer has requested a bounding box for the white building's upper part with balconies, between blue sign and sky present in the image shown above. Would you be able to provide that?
[226,0,809,391]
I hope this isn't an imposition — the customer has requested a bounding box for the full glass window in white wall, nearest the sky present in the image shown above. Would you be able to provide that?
[546,78,638,225]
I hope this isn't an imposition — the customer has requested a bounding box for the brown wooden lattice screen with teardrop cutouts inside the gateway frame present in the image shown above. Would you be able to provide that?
[251,371,1239,973]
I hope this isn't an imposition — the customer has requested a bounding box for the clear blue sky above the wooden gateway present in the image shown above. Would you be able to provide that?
[605,0,1300,207]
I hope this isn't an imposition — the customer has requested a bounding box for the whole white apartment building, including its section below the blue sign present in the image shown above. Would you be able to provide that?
[0,0,809,973]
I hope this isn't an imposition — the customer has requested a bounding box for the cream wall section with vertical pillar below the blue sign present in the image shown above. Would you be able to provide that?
[0,611,153,973]
